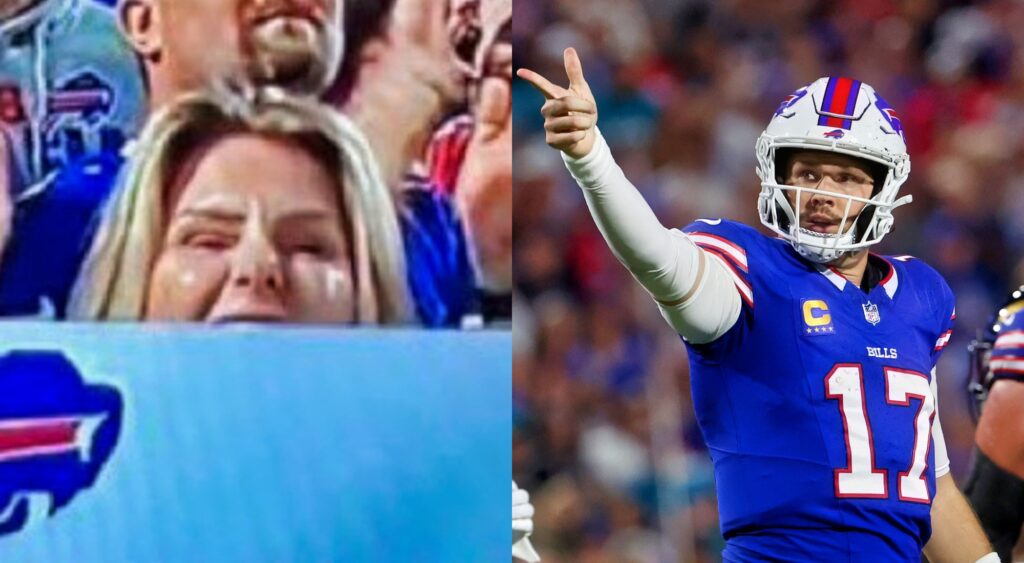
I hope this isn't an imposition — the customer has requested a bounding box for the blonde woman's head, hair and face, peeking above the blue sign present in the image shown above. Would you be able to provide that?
[69,89,412,324]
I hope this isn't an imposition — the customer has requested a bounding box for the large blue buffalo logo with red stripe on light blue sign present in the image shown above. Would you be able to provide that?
[0,352,123,535]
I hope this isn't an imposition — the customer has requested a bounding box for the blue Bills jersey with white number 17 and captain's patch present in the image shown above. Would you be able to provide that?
[684,220,954,562]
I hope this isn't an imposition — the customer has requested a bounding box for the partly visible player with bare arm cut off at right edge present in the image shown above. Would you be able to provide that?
[964,286,1024,561]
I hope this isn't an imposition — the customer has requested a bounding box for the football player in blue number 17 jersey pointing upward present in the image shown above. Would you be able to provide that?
[518,49,998,562]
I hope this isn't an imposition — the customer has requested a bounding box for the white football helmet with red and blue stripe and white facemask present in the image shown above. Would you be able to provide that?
[757,77,912,264]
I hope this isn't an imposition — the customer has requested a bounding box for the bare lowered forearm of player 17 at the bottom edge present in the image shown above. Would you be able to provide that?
[925,473,992,563]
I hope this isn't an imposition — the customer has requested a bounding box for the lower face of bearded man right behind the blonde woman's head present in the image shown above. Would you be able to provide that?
[158,0,343,93]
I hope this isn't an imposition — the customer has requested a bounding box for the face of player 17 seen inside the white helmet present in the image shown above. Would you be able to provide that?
[785,150,874,234]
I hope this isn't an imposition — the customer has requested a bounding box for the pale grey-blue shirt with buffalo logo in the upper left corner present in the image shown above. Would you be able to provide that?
[0,0,145,195]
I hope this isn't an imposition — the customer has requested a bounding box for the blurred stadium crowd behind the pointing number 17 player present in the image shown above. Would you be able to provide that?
[513,0,1024,563]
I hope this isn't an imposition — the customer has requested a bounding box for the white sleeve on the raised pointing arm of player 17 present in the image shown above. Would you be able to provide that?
[562,131,740,344]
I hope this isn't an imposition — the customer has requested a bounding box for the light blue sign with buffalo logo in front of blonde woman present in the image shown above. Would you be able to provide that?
[0,323,511,563]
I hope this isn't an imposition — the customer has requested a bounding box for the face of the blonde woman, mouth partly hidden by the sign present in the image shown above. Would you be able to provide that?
[145,134,354,322]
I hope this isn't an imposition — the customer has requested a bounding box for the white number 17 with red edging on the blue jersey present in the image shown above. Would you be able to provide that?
[825,363,935,503]
